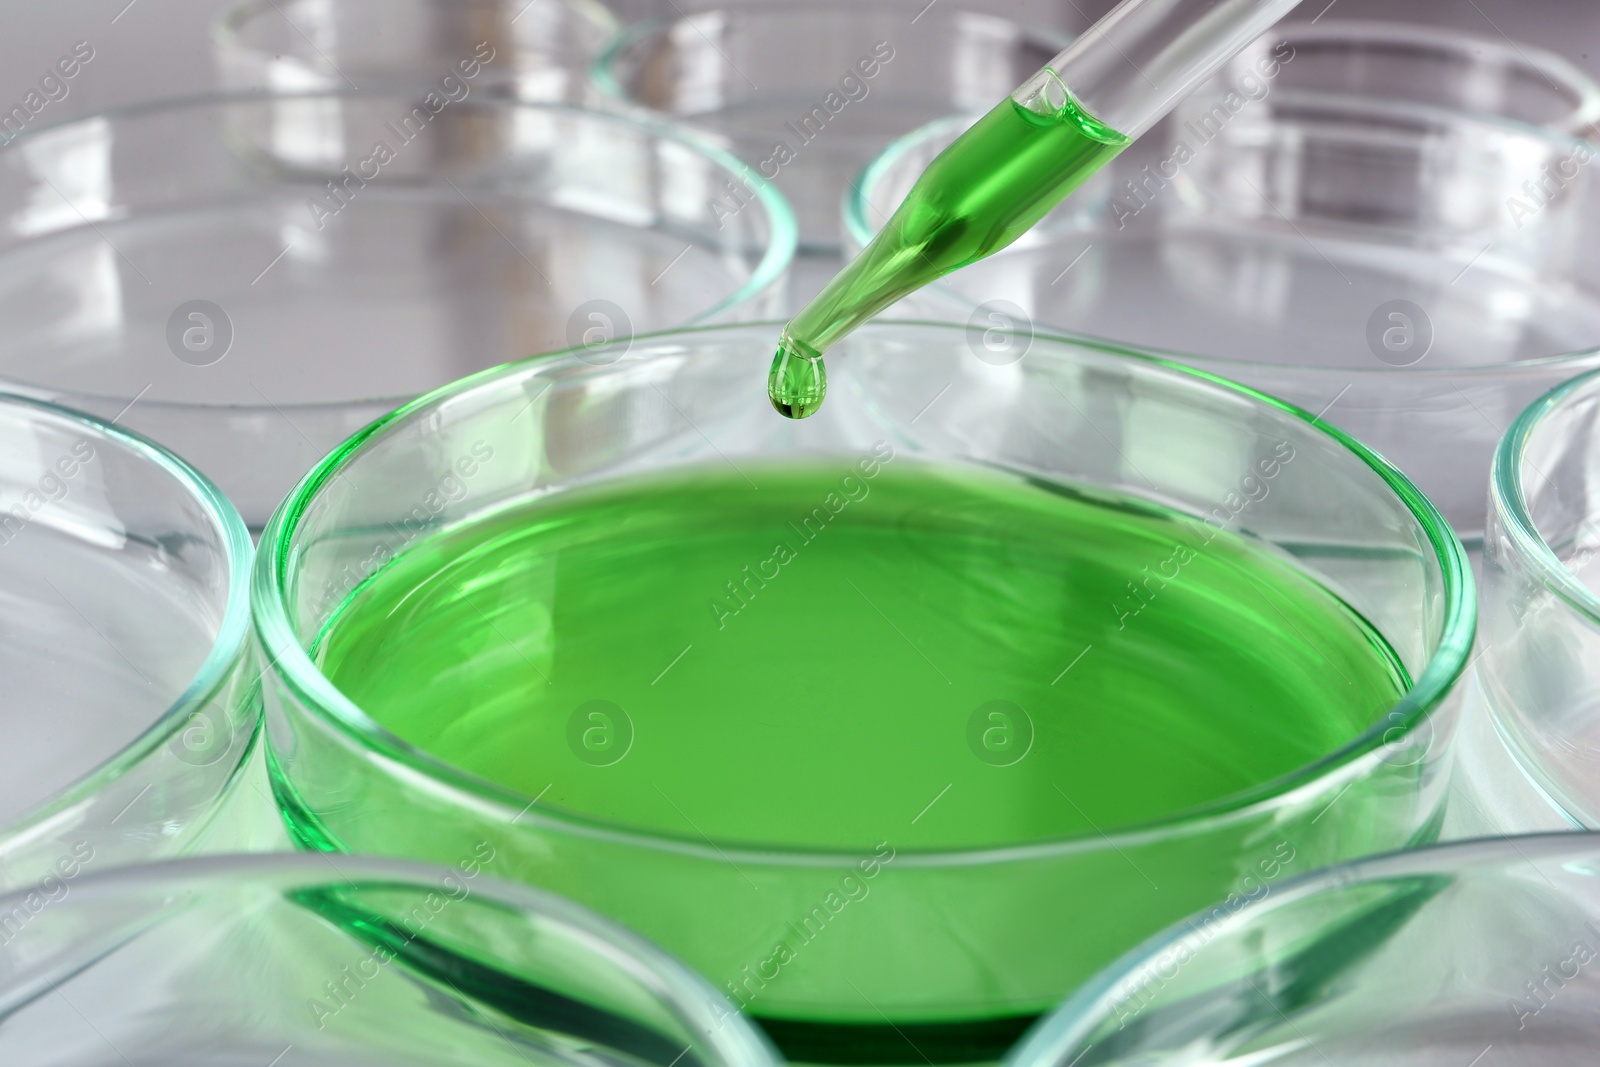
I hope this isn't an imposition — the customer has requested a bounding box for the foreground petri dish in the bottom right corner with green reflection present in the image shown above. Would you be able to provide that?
[1005,833,1600,1067]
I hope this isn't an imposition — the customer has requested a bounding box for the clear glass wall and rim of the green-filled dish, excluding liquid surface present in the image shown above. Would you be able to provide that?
[254,323,1475,1062]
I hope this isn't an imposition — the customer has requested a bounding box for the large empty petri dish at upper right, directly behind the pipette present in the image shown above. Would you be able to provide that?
[845,83,1600,549]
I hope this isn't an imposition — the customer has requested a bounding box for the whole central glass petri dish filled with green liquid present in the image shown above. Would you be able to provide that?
[254,323,1475,1062]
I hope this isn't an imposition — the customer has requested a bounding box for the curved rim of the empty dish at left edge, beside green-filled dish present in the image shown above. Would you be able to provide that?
[0,390,254,835]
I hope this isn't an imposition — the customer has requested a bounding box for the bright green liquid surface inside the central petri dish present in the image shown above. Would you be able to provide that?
[315,460,1405,849]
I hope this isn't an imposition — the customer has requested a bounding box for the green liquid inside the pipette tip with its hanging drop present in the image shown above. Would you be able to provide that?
[766,84,1130,419]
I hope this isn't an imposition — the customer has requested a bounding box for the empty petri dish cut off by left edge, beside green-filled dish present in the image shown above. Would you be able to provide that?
[0,394,252,895]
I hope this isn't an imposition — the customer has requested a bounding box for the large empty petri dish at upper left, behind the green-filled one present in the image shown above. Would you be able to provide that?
[0,93,794,530]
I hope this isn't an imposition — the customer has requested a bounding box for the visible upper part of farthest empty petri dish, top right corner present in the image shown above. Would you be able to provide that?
[1211,19,1600,136]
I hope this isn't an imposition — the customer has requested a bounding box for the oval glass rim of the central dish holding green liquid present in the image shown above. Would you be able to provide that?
[251,320,1477,867]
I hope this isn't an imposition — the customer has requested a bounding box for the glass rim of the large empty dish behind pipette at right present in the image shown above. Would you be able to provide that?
[840,101,1600,381]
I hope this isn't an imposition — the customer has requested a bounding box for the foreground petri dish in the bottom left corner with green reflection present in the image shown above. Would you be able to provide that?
[0,843,778,1067]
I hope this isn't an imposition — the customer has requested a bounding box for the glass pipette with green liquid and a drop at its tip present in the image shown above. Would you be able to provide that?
[766,0,1299,419]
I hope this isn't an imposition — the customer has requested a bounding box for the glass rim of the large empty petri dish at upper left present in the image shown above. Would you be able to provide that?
[0,90,800,414]
